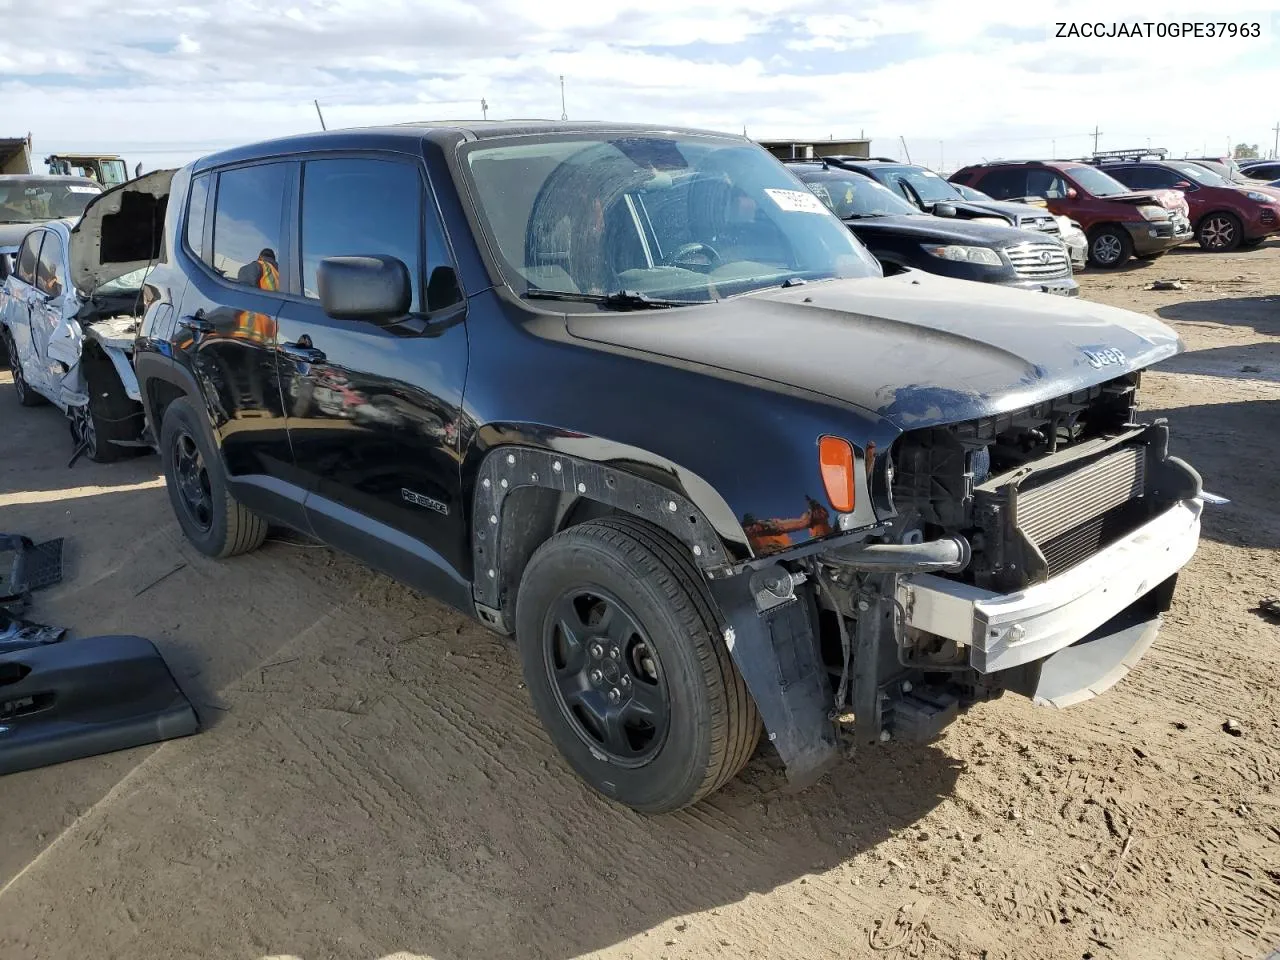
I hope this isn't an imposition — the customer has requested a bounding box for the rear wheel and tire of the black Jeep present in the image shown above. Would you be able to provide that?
[160,398,268,559]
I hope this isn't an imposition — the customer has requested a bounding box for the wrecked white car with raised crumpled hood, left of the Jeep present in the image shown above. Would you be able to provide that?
[0,170,173,462]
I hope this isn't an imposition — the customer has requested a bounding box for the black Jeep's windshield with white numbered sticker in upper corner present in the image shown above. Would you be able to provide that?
[465,136,879,301]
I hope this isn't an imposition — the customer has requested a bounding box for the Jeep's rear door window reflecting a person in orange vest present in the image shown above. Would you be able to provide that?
[205,164,289,291]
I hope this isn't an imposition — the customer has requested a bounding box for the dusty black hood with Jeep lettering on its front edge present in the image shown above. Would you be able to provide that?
[566,270,1181,430]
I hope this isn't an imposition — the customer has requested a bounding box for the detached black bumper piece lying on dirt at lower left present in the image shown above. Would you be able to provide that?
[0,636,198,774]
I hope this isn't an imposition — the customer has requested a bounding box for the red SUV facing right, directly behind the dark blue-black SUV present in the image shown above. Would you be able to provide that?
[950,160,1192,269]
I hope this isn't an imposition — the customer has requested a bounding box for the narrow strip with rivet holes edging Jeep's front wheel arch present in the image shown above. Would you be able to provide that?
[471,444,746,622]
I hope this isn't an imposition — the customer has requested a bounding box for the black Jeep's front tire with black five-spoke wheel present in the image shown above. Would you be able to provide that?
[516,517,760,814]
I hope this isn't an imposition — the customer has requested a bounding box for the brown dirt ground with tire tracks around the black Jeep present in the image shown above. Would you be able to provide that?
[0,241,1280,960]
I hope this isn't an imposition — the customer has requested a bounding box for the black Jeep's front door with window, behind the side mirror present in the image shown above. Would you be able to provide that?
[276,156,470,594]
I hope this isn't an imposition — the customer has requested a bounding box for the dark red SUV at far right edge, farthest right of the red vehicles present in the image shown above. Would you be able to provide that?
[1096,151,1280,252]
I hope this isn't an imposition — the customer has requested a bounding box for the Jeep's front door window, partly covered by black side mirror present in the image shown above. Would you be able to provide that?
[302,157,422,310]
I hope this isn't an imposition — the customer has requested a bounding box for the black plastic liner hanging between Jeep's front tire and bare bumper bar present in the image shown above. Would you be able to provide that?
[709,576,840,787]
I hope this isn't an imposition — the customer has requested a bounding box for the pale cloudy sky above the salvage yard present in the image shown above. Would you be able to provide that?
[0,0,1280,172]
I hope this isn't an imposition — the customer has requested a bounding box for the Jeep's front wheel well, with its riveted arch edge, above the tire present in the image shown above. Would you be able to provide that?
[472,448,731,631]
